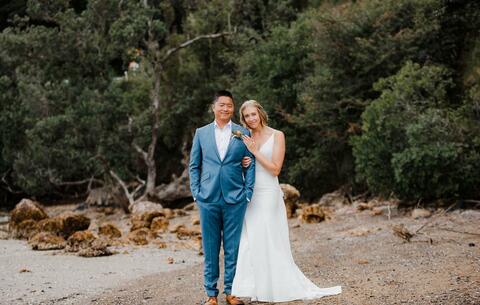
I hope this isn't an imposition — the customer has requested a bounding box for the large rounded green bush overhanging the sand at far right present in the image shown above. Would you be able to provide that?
[352,62,479,199]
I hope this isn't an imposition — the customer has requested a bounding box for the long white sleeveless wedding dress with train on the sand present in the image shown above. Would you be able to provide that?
[232,134,342,302]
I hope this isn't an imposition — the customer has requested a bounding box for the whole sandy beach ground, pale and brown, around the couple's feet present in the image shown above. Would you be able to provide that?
[0,206,480,305]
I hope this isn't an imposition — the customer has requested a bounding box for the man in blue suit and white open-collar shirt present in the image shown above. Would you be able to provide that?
[190,90,255,305]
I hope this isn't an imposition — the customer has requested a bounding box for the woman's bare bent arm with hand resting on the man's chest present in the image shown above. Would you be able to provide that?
[244,131,285,176]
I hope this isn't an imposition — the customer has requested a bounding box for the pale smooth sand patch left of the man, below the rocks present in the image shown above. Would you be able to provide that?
[0,240,202,305]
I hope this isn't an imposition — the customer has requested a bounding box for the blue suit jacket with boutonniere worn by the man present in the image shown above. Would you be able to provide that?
[189,122,255,204]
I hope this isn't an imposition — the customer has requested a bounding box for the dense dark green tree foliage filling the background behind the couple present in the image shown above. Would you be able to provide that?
[0,0,480,204]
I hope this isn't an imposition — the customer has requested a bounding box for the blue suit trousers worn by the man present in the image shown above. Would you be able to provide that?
[197,199,247,296]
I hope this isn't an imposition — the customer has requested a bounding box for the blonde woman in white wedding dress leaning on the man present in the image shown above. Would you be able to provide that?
[232,100,342,302]
